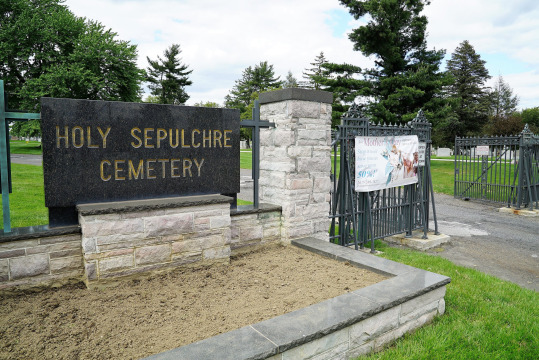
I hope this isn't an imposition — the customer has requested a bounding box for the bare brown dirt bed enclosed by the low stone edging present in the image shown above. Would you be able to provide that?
[0,246,384,359]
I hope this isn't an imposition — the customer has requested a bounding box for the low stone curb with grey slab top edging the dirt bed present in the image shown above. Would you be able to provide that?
[146,238,451,360]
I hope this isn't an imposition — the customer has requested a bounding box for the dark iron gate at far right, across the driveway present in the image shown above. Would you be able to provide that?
[454,125,539,209]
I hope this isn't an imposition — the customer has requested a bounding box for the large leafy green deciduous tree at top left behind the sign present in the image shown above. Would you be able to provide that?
[0,0,143,136]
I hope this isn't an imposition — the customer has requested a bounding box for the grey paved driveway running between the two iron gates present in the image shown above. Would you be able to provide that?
[430,194,539,291]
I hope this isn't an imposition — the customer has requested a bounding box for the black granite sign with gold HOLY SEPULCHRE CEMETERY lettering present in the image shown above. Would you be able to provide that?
[41,98,240,224]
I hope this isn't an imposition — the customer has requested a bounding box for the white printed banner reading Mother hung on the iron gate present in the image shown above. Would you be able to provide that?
[355,135,419,192]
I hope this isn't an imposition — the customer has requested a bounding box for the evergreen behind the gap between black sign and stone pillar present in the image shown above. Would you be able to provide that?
[225,61,283,117]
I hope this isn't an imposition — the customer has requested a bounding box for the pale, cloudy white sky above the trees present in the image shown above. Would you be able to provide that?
[65,0,539,108]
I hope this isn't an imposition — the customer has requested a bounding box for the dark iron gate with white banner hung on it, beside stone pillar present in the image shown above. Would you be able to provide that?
[330,105,438,252]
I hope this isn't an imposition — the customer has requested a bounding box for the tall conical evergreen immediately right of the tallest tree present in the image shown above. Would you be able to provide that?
[444,40,490,142]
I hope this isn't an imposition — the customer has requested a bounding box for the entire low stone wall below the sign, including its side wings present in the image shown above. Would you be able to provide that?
[0,195,281,290]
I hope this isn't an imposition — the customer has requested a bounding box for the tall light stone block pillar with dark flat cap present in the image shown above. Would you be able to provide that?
[260,89,333,243]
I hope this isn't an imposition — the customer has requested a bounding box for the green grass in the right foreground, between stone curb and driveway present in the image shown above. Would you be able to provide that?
[358,242,539,360]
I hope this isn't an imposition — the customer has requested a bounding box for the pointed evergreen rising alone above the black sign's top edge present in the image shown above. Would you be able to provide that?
[146,44,193,105]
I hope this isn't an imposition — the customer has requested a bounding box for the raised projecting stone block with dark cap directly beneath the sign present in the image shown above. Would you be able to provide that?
[77,195,231,286]
